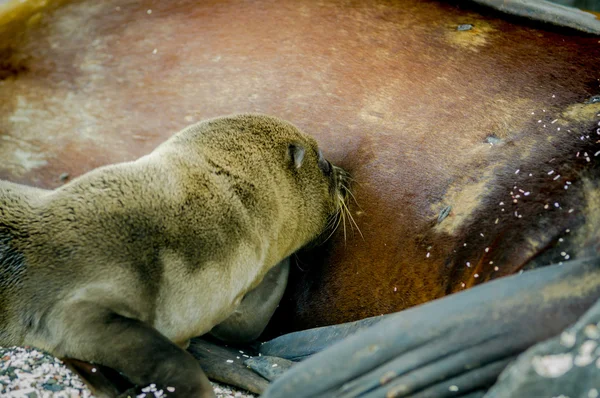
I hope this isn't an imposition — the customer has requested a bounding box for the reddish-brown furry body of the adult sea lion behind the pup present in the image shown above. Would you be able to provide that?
[0,0,600,331]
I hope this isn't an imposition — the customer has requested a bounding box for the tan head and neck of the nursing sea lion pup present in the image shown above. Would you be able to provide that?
[157,114,349,261]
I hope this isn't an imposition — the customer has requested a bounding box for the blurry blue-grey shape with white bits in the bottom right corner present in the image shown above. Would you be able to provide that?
[486,294,600,398]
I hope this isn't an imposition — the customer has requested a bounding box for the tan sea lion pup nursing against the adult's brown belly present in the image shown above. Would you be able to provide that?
[0,115,346,397]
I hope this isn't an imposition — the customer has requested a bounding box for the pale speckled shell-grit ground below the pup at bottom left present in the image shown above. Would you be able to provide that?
[0,347,256,398]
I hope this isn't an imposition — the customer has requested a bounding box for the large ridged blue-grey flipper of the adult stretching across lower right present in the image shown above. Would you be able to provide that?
[264,258,600,398]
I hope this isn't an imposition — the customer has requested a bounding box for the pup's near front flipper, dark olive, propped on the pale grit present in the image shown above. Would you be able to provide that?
[51,303,214,397]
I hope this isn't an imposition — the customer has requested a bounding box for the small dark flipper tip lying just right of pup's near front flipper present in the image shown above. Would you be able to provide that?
[188,338,269,394]
